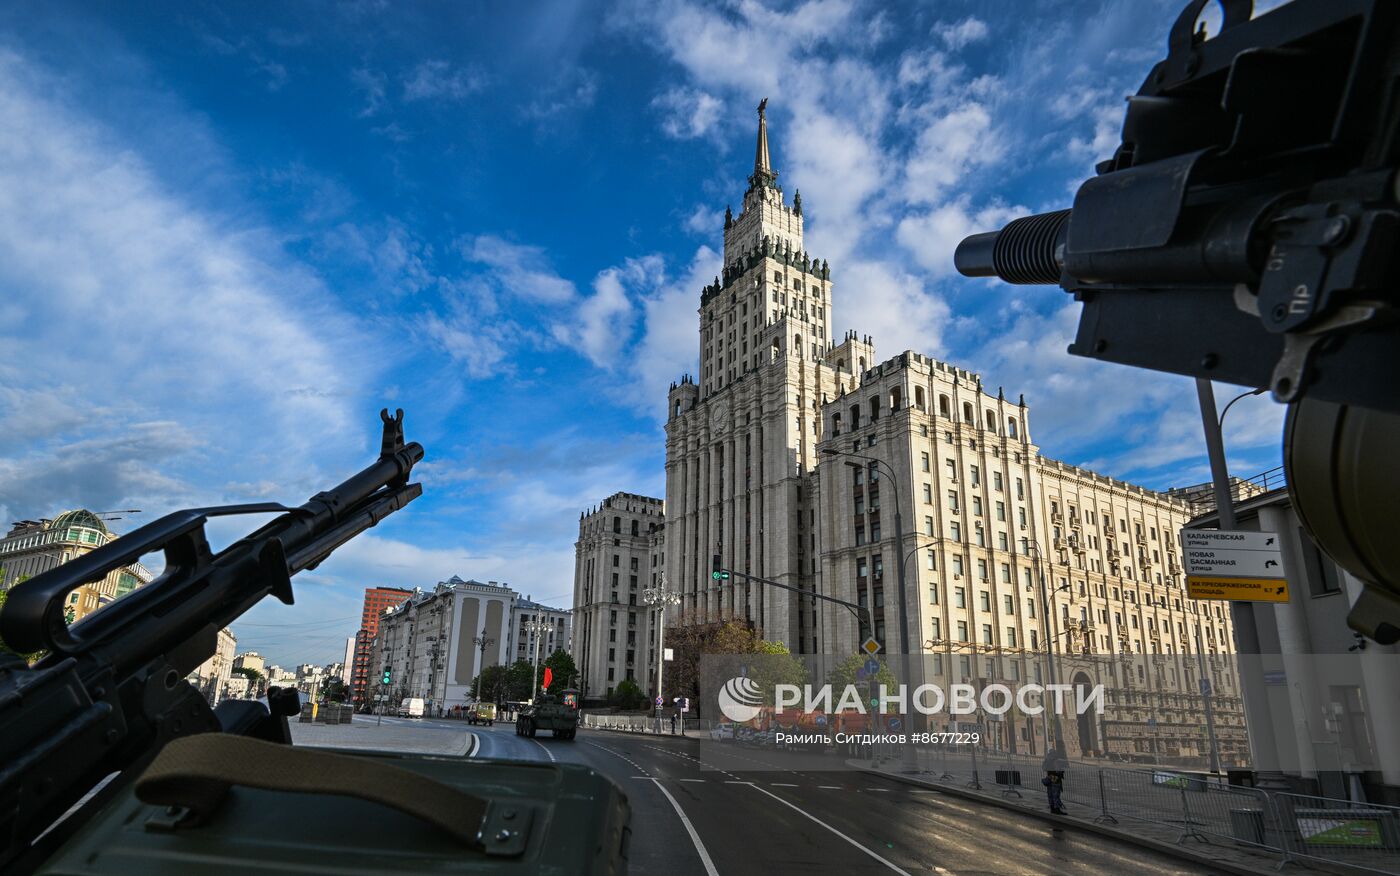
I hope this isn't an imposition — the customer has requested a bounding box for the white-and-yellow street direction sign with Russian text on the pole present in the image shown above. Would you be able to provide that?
[1182,529,1288,602]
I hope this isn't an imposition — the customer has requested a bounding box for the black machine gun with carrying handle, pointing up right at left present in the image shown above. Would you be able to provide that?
[0,410,423,872]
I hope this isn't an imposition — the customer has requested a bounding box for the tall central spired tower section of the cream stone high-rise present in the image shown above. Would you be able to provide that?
[665,101,837,651]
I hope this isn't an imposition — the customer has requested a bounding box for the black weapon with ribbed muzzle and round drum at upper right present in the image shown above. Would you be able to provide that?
[955,0,1400,642]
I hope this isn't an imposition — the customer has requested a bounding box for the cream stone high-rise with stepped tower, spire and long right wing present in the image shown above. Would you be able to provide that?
[575,100,1246,763]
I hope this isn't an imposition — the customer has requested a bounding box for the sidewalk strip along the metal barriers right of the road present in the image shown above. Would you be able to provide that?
[846,760,1355,876]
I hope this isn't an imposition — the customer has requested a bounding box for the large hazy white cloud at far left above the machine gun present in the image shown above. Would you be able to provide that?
[0,53,375,516]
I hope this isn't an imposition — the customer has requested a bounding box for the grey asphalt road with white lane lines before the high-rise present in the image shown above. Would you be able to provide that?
[386,721,1226,876]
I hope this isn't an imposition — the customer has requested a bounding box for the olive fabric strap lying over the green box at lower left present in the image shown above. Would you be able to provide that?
[136,733,531,855]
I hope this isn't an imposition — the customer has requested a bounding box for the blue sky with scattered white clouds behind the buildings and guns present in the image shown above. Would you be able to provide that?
[0,0,1282,663]
